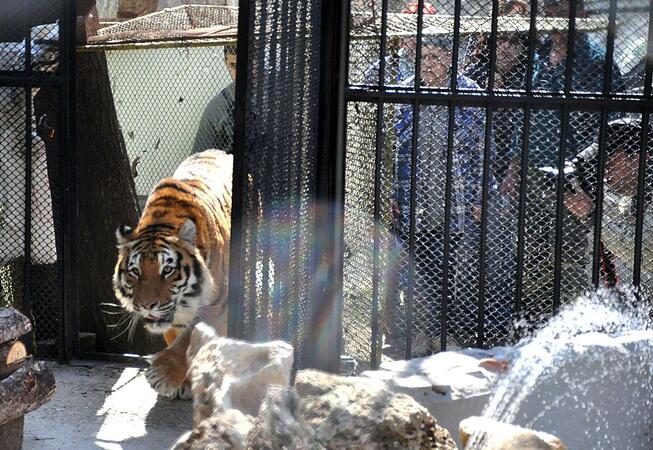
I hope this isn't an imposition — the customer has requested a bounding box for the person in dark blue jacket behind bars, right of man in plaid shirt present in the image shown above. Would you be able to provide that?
[502,0,622,331]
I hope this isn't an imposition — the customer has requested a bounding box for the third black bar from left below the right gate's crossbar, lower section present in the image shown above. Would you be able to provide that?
[440,103,460,351]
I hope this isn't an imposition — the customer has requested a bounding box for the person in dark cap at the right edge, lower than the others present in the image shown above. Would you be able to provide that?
[564,118,653,287]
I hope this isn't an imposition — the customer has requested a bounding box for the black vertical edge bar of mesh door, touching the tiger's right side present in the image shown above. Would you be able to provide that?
[228,0,251,338]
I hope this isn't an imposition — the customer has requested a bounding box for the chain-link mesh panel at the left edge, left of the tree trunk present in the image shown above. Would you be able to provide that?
[0,12,62,357]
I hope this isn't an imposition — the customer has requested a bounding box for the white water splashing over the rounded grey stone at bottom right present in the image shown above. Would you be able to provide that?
[467,287,653,449]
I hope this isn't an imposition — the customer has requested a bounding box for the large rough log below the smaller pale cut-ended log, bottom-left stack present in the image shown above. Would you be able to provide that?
[0,361,55,424]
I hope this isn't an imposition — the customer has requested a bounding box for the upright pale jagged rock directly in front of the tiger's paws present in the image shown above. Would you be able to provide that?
[173,323,293,450]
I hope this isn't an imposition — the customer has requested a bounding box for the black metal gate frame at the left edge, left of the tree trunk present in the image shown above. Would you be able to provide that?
[0,0,78,361]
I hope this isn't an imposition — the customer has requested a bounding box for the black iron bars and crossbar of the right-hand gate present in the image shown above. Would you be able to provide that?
[339,0,653,367]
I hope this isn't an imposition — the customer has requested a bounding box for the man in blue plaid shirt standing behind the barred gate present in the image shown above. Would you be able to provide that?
[394,36,492,351]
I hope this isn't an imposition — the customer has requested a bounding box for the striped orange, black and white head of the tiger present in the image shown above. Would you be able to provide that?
[113,220,214,333]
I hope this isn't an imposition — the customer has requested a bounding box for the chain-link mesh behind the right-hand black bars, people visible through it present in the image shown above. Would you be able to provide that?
[344,0,650,365]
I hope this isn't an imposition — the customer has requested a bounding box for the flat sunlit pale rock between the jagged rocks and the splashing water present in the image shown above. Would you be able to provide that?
[361,348,509,447]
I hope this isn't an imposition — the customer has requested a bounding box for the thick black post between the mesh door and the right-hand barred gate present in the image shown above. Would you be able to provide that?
[305,0,348,373]
